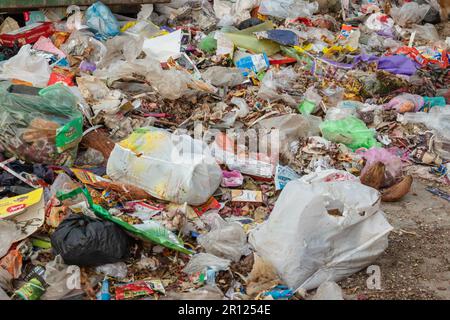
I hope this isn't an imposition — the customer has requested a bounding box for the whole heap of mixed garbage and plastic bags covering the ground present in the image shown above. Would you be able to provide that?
[0,0,450,300]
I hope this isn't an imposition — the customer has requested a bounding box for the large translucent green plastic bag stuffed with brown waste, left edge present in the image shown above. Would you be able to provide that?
[0,82,83,165]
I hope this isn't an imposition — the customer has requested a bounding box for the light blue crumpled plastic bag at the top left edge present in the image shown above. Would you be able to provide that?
[86,1,120,40]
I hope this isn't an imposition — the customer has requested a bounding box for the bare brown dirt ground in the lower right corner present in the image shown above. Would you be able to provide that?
[339,179,450,299]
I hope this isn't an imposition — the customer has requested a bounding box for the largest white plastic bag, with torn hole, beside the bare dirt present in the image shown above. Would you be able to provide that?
[249,180,392,290]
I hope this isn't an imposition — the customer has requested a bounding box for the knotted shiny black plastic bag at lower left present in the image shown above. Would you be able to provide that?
[51,214,131,266]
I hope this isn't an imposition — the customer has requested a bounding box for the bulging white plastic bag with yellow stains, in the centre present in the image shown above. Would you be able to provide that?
[106,127,222,205]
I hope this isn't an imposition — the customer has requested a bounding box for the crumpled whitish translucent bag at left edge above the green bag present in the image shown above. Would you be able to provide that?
[0,44,52,88]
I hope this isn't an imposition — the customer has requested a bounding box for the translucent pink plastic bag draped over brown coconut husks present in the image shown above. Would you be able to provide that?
[358,148,402,188]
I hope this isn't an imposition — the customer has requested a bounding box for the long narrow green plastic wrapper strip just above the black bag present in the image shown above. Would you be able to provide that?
[56,188,194,254]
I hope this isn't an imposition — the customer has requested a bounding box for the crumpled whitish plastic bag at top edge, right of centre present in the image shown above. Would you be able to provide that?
[259,0,319,19]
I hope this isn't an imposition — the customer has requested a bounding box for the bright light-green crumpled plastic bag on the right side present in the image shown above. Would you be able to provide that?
[319,116,381,151]
